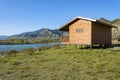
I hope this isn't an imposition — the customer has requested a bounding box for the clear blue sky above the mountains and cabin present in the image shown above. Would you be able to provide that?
[0,0,120,35]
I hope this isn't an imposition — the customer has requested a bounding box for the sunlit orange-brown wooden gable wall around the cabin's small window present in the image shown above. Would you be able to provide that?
[69,20,91,44]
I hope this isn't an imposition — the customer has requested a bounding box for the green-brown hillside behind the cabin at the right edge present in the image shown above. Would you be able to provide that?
[99,18,120,39]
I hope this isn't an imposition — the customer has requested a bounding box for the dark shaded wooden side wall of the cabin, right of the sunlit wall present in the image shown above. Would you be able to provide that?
[92,22,111,44]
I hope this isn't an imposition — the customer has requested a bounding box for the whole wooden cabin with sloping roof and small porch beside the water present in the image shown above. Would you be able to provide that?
[59,17,114,46]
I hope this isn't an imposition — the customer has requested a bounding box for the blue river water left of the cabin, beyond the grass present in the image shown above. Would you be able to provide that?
[0,43,60,52]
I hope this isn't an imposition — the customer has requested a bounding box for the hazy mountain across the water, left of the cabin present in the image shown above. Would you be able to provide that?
[8,28,61,40]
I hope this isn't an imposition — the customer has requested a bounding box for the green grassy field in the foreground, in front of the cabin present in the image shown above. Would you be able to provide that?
[0,47,120,80]
